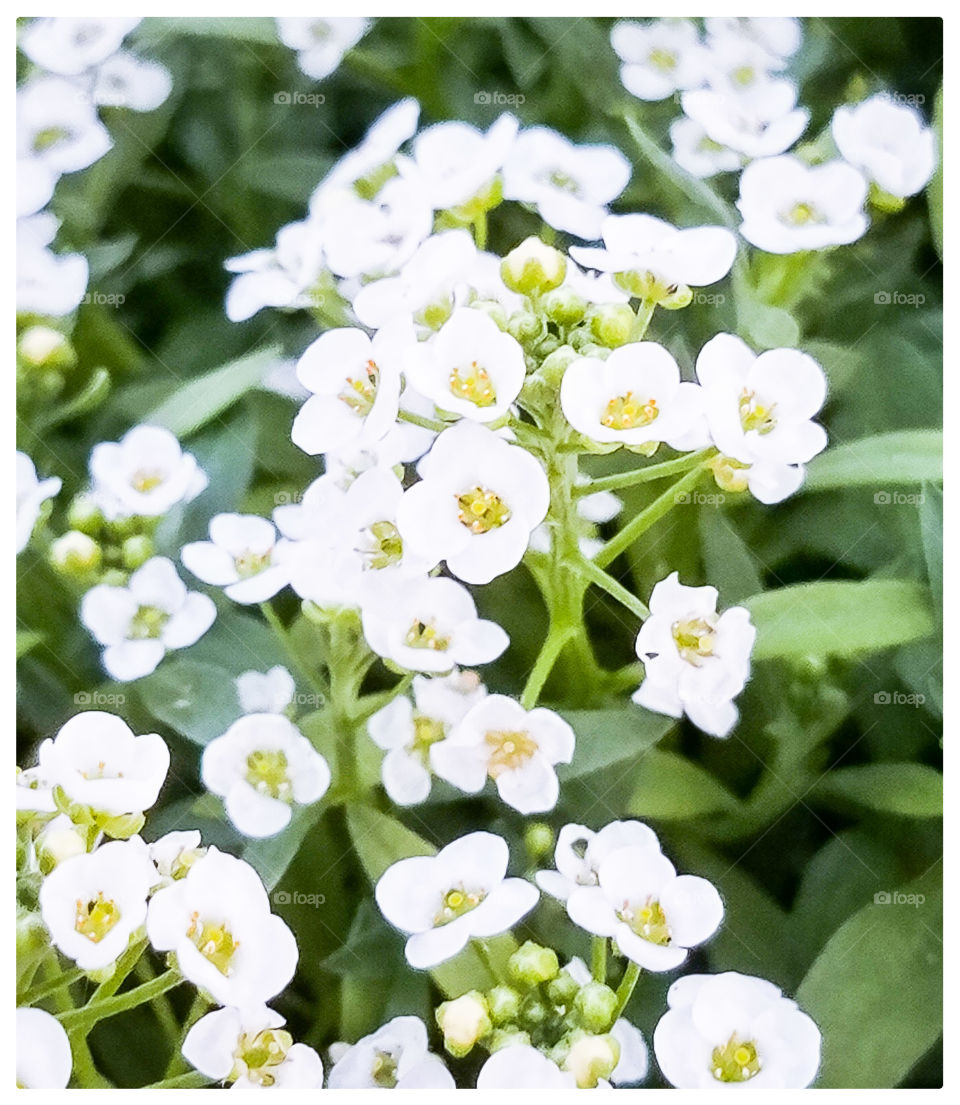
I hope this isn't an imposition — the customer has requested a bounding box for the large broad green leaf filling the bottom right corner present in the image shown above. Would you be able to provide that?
[797,875,942,1088]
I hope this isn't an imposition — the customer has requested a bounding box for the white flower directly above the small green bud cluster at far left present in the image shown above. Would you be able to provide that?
[89,425,208,518]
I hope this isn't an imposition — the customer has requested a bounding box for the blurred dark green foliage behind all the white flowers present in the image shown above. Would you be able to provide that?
[18,18,942,1086]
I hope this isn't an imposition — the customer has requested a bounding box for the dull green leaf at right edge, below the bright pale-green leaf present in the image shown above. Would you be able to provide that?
[815,764,943,818]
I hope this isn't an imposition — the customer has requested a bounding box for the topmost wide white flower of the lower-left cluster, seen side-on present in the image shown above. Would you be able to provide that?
[38,709,170,814]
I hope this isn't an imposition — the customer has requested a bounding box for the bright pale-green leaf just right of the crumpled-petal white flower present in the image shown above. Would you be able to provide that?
[743,579,935,660]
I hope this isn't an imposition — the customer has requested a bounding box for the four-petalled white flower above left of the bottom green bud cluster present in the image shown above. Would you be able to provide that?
[376,832,539,969]
